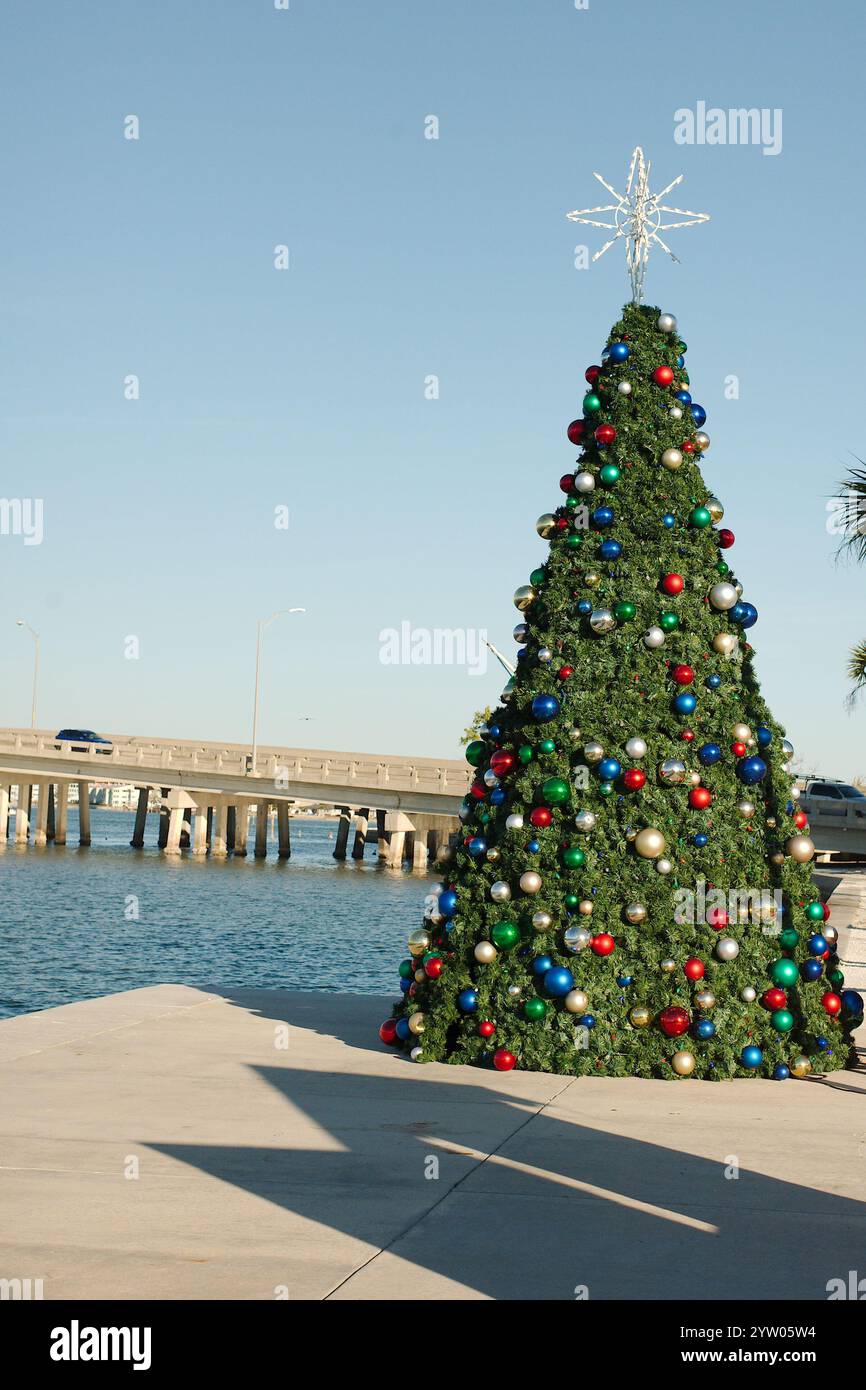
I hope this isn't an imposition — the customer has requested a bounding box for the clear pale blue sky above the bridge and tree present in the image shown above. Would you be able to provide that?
[0,0,866,777]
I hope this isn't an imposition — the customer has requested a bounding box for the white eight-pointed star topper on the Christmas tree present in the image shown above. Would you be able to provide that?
[566,145,709,304]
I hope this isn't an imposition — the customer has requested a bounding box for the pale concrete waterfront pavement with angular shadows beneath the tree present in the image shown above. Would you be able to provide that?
[0,986,866,1300]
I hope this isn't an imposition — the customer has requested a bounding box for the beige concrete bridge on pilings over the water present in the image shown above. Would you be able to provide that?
[0,728,470,869]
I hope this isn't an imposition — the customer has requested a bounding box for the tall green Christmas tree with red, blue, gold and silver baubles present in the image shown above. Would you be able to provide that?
[379,152,863,1080]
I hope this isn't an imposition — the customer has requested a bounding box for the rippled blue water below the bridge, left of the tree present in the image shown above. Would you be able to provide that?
[0,808,434,1016]
